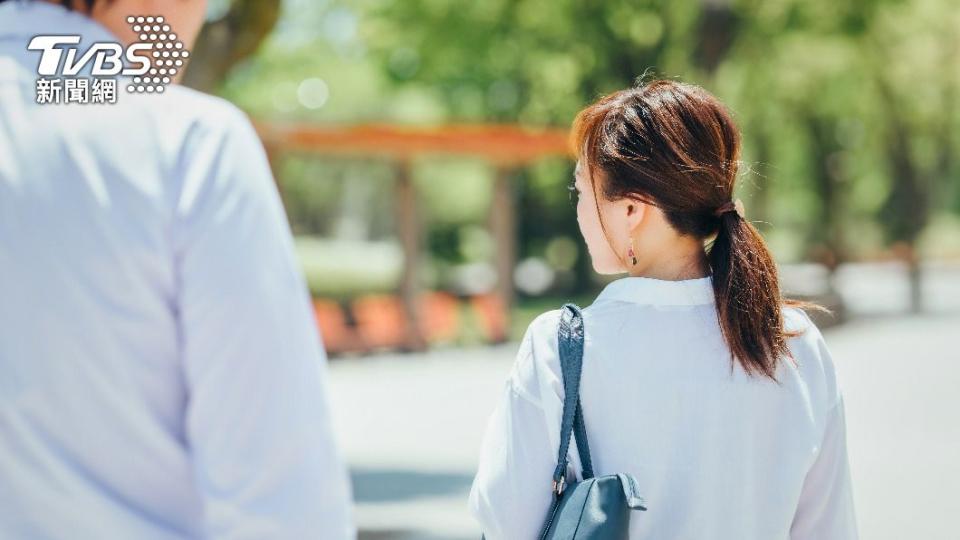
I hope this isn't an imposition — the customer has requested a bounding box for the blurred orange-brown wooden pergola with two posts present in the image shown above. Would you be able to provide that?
[255,122,569,349]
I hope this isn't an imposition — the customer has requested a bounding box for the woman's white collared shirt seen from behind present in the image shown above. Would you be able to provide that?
[470,277,857,540]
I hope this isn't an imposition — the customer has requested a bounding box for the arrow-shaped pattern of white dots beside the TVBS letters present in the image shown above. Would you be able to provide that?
[127,16,190,94]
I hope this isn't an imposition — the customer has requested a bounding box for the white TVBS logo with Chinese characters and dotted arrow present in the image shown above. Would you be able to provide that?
[27,16,190,104]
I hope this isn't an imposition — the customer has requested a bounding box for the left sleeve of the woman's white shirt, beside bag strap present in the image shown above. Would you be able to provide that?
[469,316,562,540]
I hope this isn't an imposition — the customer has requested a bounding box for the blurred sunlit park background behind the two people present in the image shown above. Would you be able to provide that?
[185,0,960,540]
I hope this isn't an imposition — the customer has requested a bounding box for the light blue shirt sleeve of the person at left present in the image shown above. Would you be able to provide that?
[172,103,355,540]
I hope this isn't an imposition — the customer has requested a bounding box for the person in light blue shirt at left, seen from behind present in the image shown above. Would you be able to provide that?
[0,0,355,540]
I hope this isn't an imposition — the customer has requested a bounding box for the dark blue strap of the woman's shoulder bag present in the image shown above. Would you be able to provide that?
[553,304,593,495]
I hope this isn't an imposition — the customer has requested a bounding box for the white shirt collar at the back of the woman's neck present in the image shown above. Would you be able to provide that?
[596,276,714,306]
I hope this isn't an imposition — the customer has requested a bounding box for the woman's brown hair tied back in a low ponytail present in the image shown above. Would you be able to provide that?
[573,80,819,381]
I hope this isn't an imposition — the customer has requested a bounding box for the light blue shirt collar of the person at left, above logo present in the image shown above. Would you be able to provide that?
[0,0,120,44]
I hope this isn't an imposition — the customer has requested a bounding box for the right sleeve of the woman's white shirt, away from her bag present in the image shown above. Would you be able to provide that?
[790,396,858,540]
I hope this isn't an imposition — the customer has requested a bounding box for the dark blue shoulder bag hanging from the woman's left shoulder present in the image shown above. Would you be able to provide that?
[540,304,647,540]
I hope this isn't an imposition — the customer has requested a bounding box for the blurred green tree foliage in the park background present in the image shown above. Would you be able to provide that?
[214,0,960,308]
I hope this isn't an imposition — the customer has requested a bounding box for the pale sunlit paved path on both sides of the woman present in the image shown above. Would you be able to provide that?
[331,315,960,540]
